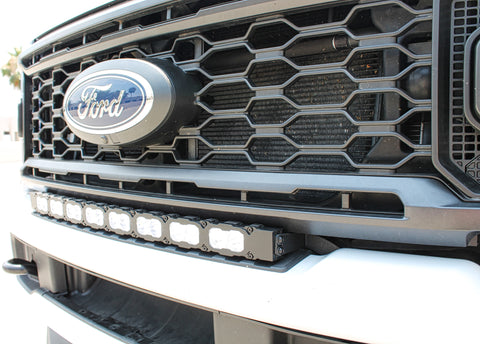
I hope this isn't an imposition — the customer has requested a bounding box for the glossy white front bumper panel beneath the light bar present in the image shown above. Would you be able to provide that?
[9,207,480,344]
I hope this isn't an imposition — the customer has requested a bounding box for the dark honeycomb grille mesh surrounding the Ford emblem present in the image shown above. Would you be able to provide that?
[27,1,432,173]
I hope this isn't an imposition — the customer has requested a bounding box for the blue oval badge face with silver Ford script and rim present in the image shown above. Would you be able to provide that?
[64,73,146,131]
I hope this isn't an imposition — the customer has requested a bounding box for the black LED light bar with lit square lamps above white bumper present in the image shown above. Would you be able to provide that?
[31,192,302,262]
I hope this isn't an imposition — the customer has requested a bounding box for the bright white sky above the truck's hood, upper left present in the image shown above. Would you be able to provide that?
[0,0,113,117]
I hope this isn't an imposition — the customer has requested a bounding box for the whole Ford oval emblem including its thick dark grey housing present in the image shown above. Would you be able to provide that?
[63,59,199,145]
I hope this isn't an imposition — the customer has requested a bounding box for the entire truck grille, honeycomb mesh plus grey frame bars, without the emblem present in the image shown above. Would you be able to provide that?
[22,0,480,253]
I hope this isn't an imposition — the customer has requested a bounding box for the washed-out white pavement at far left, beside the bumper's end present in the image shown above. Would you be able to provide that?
[0,136,46,344]
